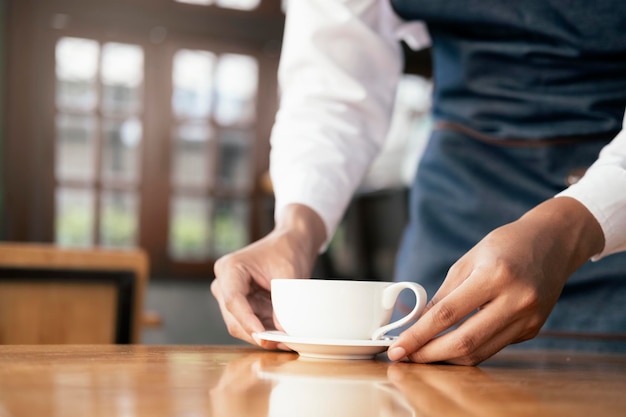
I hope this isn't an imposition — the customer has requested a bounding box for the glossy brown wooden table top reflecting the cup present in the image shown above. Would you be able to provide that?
[0,345,626,417]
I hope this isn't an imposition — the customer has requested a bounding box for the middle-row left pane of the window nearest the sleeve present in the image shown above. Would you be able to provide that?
[172,124,213,187]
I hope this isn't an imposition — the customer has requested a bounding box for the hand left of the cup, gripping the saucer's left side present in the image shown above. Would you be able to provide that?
[211,204,326,349]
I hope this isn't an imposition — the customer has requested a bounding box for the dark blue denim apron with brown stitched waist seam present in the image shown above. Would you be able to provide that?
[391,0,626,351]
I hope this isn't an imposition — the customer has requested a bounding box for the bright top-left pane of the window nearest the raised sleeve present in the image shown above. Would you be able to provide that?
[172,49,215,117]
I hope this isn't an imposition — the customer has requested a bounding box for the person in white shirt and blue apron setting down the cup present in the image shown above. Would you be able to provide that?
[212,0,626,364]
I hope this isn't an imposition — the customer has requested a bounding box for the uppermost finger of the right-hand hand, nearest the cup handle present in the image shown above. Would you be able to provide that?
[387,270,489,361]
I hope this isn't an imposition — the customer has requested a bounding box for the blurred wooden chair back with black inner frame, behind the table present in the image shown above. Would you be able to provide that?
[0,243,148,344]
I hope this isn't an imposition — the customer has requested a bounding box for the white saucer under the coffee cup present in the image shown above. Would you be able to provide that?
[257,331,395,359]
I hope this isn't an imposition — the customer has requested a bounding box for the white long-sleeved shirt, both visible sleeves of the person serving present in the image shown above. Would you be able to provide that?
[270,0,626,259]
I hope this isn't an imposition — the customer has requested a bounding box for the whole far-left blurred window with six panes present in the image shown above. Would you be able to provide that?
[55,37,144,247]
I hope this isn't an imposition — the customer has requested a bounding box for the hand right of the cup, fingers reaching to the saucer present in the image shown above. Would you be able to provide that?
[388,197,604,365]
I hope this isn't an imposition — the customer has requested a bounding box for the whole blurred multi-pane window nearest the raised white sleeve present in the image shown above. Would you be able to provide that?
[168,49,259,260]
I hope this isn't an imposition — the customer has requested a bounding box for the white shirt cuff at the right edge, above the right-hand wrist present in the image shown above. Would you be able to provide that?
[557,114,626,260]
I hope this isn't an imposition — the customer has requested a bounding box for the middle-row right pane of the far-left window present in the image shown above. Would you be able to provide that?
[102,118,142,182]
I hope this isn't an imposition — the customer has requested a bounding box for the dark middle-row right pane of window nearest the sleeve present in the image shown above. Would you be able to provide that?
[218,129,253,189]
